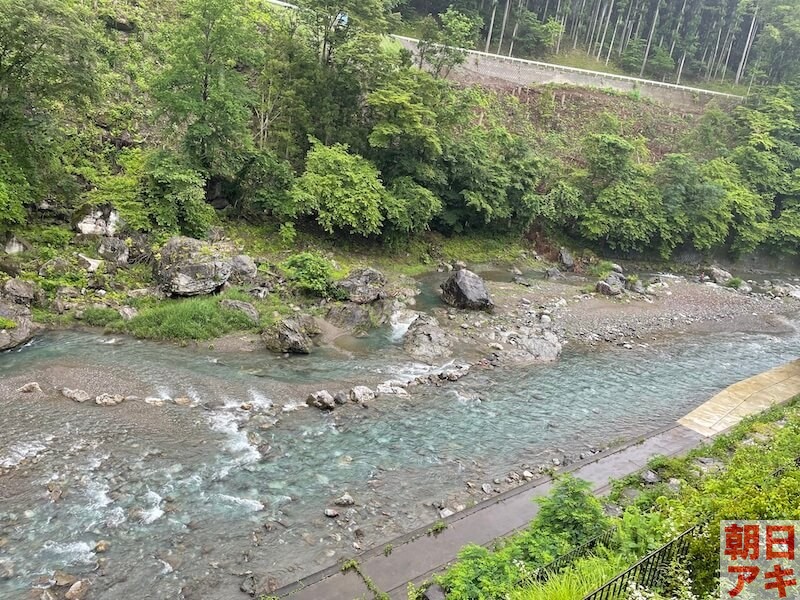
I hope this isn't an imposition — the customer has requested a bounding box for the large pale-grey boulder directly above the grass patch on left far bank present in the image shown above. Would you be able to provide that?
[156,237,233,296]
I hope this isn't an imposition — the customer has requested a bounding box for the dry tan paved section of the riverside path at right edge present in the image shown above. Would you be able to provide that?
[678,360,800,437]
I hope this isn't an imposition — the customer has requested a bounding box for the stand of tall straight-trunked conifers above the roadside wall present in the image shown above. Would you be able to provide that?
[406,0,800,84]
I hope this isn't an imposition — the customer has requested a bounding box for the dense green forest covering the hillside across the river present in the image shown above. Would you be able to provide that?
[0,0,800,258]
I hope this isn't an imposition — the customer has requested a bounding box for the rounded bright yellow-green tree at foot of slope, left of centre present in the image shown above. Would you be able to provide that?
[291,140,386,236]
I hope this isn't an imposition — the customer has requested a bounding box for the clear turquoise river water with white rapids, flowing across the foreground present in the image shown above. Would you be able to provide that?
[0,331,799,600]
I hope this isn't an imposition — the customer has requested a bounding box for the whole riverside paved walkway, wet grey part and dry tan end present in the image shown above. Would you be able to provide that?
[277,360,800,600]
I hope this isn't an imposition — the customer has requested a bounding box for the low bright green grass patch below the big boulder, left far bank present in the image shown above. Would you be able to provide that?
[126,298,253,340]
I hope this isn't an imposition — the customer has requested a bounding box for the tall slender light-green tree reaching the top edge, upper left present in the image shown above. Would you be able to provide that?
[153,0,254,178]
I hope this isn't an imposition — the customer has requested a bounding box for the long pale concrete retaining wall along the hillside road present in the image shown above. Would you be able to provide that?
[393,36,744,112]
